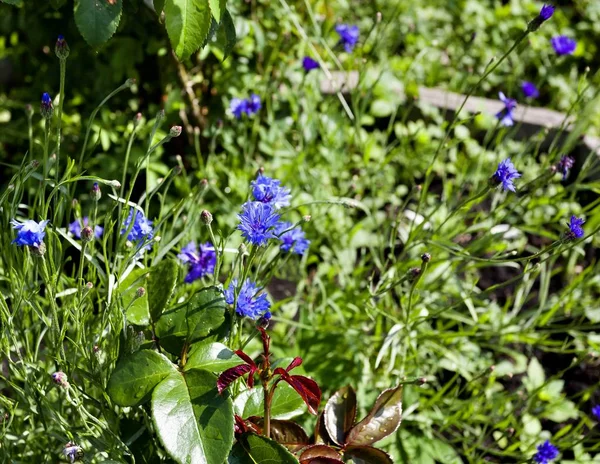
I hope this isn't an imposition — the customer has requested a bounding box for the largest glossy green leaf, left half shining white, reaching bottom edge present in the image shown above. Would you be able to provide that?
[152,369,234,464]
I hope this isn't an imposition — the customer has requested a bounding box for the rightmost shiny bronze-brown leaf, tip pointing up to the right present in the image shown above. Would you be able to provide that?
[346,385,402,446]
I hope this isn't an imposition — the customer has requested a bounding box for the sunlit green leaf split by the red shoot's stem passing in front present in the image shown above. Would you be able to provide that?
[234,383,306,420]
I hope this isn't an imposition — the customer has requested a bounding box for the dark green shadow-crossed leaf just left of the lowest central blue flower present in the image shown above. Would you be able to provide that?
[156,287,227,355]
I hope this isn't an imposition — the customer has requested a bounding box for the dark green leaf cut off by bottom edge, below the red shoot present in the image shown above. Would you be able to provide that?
[227,433,298,464]
